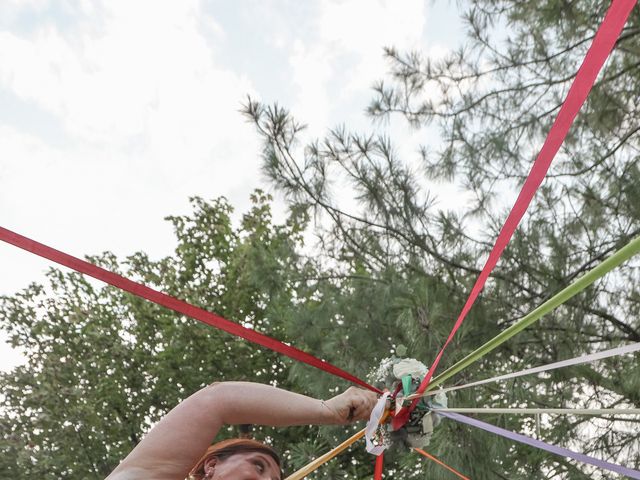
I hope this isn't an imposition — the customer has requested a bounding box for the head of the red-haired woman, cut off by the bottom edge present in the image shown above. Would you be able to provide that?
[189,438,282,480]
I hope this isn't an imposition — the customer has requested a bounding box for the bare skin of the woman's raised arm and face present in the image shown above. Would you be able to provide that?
[107,382,377,480]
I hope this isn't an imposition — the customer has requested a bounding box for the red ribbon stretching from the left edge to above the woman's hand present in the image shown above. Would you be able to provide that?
[0,227,382,394]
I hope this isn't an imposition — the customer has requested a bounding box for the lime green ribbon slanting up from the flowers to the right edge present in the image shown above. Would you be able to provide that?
[426,236,640,391]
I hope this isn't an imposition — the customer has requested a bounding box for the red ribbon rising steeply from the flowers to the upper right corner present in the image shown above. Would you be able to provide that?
[392,0,636,429]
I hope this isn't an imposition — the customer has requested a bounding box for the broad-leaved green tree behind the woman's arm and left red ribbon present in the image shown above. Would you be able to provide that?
[0,191,352,479]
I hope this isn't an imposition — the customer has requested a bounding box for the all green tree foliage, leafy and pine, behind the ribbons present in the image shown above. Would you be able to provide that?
[0,0,640,479]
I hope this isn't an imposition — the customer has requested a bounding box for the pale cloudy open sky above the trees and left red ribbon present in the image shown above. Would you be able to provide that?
[0,0,462,370]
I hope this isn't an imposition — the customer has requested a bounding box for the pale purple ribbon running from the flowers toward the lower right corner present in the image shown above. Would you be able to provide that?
[438,412,640,479]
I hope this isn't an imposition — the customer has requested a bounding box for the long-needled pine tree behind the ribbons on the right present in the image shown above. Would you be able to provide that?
[245,0,640,479]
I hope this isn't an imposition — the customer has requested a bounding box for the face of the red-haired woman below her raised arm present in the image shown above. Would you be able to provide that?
[205,452,281,480]
